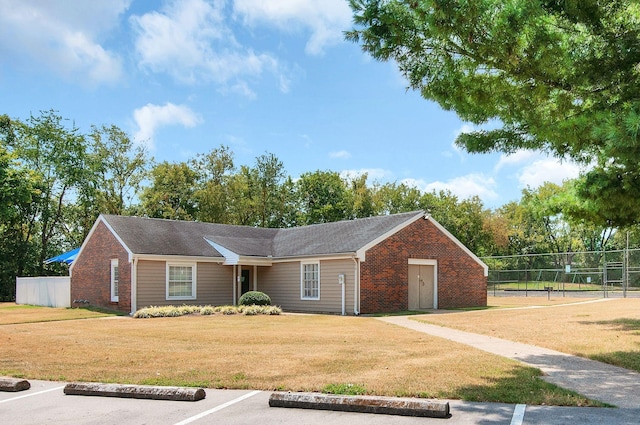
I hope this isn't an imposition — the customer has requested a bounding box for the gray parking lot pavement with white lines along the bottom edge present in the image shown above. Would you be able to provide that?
[0,380,640,425]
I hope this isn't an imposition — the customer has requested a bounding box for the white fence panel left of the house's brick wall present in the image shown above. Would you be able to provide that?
[16,276,71,307]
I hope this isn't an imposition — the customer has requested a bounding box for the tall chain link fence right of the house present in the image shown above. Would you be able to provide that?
[482,249,640,297]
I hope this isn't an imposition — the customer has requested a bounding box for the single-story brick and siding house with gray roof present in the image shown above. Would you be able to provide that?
[70,211,488,315]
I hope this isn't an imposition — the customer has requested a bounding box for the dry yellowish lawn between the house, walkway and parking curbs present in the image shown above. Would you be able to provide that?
[0,314,599,406]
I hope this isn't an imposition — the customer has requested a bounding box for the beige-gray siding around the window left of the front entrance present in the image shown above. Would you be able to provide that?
[137,260,233,308]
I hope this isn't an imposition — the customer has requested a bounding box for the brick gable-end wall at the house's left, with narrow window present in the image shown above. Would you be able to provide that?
[71,222,131,312]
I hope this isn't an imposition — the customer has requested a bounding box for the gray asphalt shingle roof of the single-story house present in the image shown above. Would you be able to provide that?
[103,211,424,258]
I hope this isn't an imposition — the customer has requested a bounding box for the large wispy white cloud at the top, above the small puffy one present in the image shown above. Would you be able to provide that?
[130,0,288,92]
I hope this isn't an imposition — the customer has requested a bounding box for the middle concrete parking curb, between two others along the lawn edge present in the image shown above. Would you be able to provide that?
[64,382,206,401]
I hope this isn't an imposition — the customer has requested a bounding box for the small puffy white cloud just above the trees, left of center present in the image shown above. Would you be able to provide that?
[133,102,202,148]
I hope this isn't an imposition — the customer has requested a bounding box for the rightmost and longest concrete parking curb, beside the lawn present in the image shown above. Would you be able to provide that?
[269,392,450,418]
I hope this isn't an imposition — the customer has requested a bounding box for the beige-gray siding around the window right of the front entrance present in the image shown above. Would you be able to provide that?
[258,260,355,314]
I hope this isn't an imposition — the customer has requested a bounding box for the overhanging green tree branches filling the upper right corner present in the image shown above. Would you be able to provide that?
[347,0,640,225]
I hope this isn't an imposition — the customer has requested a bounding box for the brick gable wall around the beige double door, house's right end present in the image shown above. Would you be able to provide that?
[360,219,487,314]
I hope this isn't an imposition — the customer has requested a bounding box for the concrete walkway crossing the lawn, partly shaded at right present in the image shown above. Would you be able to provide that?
[379,316,640,409]
